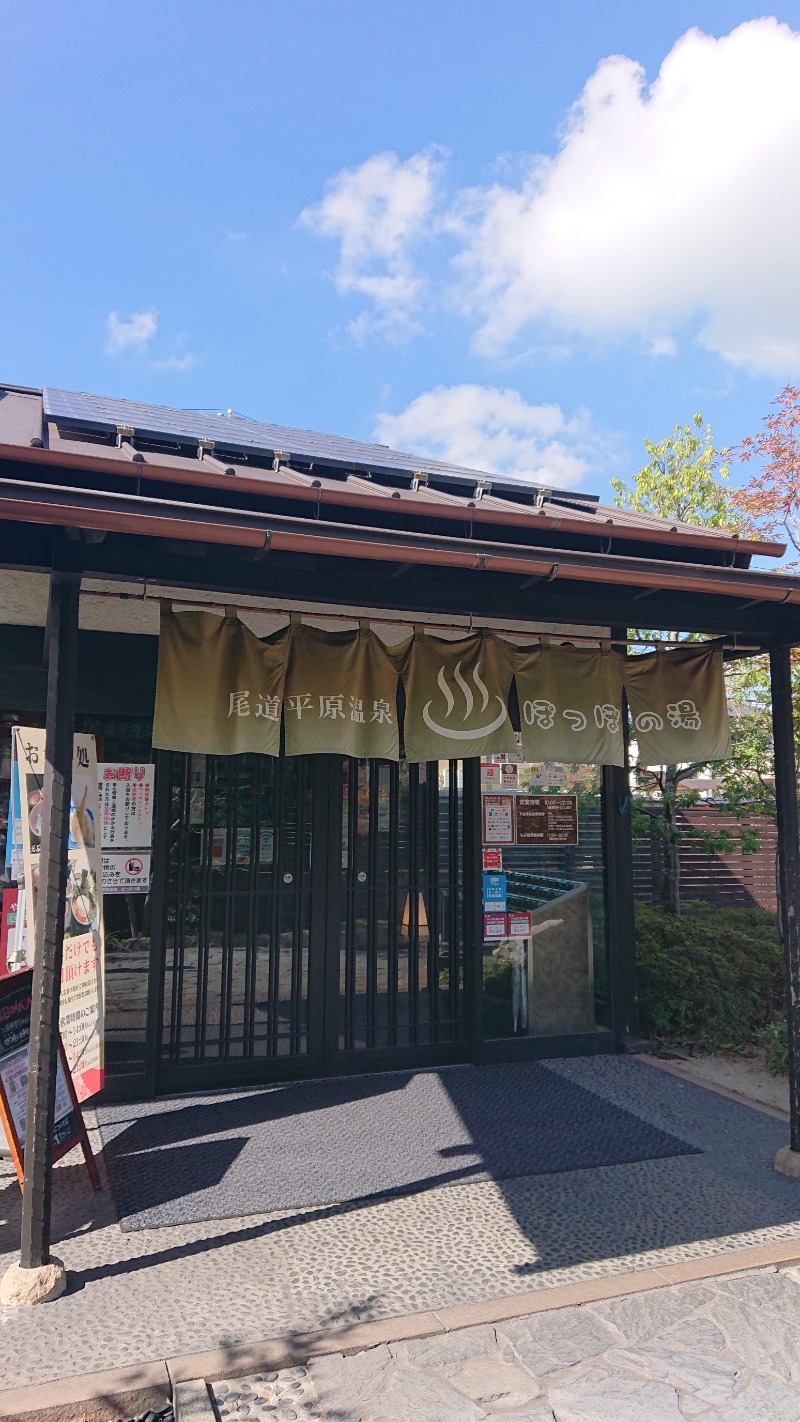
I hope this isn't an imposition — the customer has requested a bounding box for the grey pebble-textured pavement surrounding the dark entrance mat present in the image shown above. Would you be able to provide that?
[0,1058,800,1402]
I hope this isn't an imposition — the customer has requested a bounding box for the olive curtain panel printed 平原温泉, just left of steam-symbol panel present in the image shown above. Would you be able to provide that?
[284,623,408,761]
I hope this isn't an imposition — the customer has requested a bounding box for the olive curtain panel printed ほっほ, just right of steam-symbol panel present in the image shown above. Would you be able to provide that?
[516,640,625,765]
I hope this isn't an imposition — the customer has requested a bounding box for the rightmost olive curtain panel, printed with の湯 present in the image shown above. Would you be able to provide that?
[624,647,730,765]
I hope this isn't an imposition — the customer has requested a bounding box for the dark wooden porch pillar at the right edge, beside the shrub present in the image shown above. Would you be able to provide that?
[770,647,800,1152]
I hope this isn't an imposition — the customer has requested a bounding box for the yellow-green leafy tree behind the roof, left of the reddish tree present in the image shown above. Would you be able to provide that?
[611,414,757,913]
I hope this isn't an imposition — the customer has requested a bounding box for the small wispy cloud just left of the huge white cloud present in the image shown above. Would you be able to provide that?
[300,149,442,341]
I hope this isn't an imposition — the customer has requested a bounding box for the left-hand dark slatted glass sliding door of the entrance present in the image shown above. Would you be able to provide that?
[158,754,311,1086]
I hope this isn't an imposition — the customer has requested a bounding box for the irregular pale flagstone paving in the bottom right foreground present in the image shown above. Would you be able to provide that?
[209,1268,800,1422]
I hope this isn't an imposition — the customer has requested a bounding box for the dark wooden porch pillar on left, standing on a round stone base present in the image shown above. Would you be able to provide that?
[20,572,81,1268]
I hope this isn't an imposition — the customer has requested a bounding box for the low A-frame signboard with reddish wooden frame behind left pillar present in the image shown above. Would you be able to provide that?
[0,968,99,1190]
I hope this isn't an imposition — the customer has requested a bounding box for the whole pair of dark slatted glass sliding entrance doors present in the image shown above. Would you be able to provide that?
[149,752,467,1091]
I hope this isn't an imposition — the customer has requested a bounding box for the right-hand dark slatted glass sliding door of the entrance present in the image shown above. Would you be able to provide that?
[338,759,466,1061]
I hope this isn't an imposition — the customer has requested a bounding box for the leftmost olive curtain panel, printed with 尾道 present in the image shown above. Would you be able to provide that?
[153,603,288,755]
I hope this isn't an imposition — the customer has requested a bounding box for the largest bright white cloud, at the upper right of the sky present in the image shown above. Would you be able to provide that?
[448,18,800,378]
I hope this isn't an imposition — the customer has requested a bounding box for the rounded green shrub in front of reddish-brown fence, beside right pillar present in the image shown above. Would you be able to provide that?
[637,903,784,1051]
